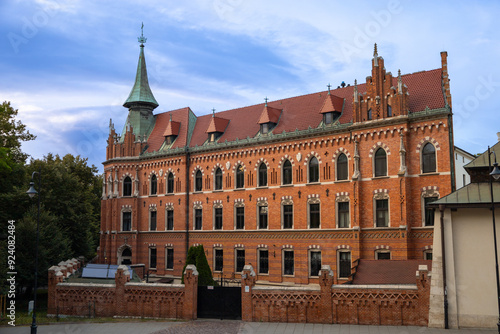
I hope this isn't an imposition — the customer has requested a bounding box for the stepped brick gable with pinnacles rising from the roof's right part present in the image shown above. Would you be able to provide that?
[353,44,409,123]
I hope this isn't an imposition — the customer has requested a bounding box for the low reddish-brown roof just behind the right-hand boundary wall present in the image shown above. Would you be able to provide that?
[352,260,432,285]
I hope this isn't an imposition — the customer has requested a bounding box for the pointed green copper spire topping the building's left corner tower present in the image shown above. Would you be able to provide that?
[123,23,158,109]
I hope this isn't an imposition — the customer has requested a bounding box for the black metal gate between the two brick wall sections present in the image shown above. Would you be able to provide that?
[198,286,241,320]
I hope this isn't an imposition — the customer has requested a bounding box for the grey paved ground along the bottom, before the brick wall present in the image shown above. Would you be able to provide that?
[0,320,496,334]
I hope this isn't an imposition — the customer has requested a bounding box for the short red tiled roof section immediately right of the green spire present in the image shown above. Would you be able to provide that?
[147,107,192,152]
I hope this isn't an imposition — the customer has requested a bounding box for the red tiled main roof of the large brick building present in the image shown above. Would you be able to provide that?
[148,68,445,152]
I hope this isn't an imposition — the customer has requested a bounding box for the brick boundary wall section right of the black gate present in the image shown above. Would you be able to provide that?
[241,265,430,326]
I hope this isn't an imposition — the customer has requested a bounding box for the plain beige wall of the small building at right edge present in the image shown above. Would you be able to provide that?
[429,209,500,328]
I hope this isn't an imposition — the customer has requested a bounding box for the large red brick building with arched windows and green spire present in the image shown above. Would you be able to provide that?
[98,41,454,284]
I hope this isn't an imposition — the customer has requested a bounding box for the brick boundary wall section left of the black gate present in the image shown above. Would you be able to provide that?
[47,264,198,319]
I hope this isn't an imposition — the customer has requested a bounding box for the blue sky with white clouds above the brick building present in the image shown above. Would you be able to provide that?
[0,0,500,170]
